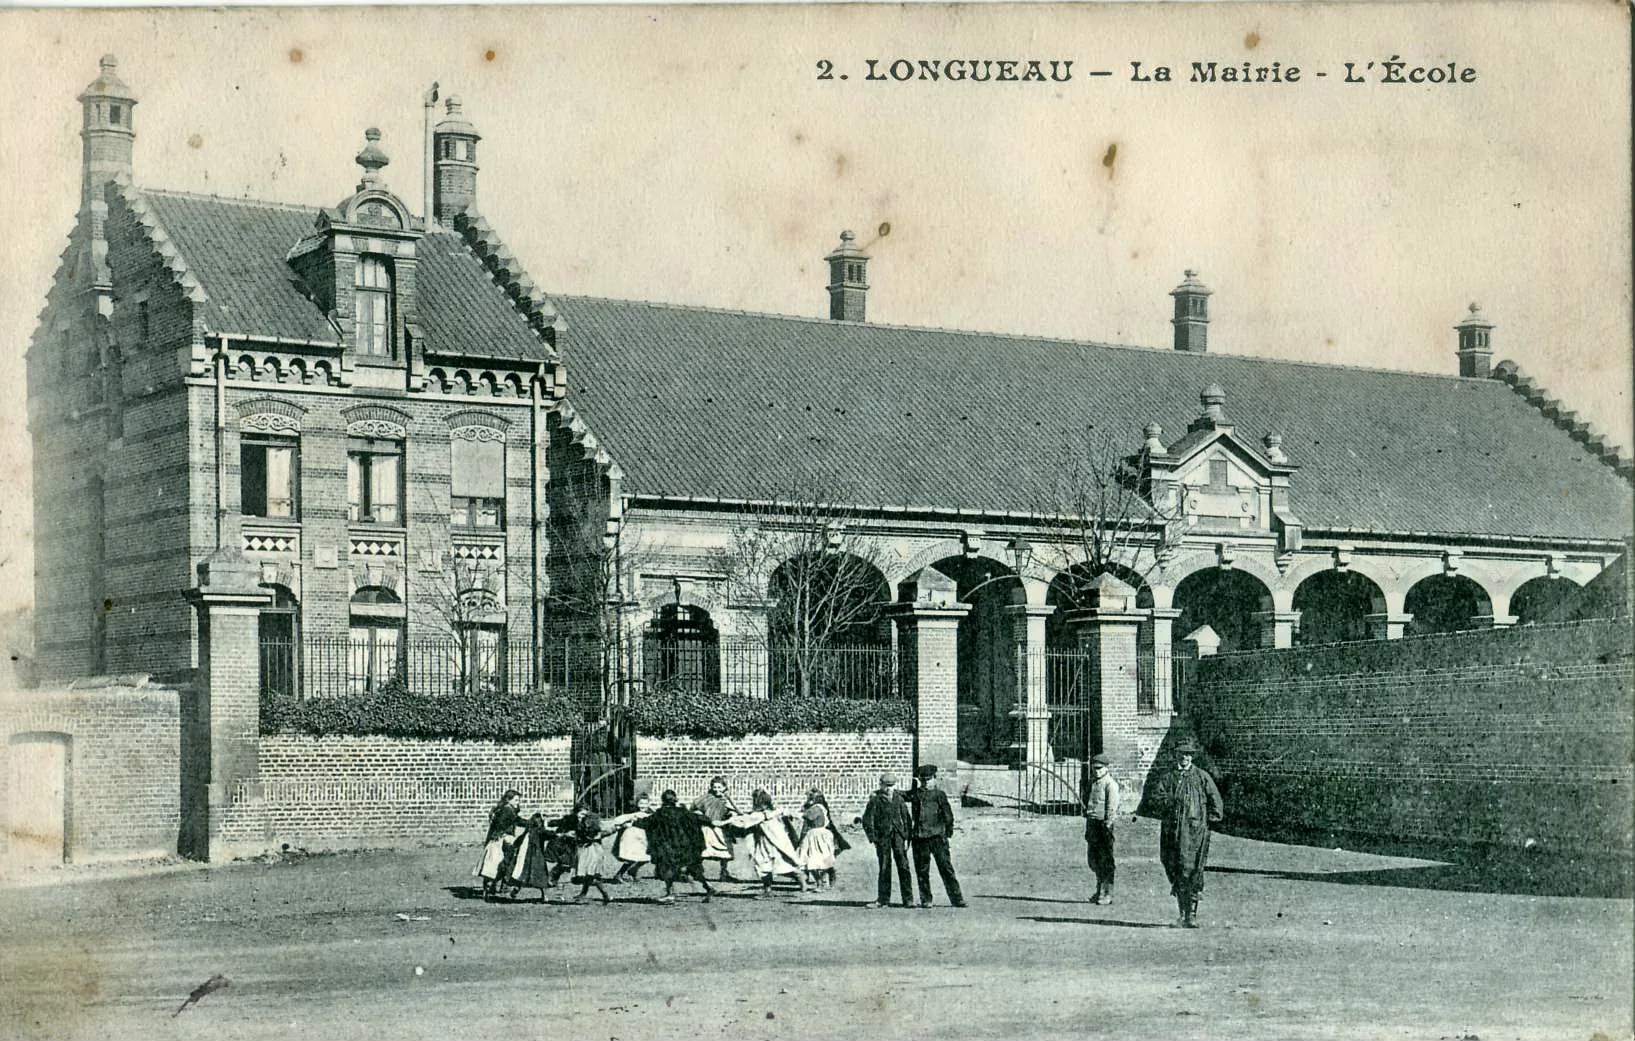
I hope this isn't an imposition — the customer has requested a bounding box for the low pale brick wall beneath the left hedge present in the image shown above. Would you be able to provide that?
[224,734,574,851]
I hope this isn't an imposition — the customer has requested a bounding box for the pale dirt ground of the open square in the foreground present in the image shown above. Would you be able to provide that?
[0,811,1635,1041]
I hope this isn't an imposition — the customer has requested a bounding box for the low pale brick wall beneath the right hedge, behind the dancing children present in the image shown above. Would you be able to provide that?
[636,730,914,820]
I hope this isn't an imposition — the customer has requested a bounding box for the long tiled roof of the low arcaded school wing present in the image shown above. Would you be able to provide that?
[553,296,1632,538]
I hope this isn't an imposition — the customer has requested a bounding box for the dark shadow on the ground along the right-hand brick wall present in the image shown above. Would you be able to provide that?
[1208,832,1635,899]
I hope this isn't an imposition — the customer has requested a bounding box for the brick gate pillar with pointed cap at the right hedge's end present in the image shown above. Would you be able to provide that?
[891,567,971,786]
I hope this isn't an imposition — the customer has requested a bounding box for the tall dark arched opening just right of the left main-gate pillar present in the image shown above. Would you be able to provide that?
[932,557,1024,765]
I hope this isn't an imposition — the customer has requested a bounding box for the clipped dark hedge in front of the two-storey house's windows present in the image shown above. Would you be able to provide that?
[262,685,585,740]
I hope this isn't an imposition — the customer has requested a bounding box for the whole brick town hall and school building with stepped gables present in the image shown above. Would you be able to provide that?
[28,59,1632,804]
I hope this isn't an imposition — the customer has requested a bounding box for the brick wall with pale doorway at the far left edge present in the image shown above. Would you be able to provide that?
[0,678,181,863]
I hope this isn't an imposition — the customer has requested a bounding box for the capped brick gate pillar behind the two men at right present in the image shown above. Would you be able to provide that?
[1069,574,1148,778]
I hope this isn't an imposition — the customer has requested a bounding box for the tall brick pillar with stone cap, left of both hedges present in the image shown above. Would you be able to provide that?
[180,549,271,860]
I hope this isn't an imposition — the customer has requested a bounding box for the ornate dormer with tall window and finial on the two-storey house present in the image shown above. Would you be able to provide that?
[286,127,425,386]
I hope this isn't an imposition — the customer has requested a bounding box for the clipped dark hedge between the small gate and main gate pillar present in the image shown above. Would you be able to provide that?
[629,691,914,737]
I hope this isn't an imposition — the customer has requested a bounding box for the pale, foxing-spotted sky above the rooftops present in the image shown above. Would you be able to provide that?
[0,2,1635,608]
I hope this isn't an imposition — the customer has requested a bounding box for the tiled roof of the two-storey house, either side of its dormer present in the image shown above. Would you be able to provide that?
[142,190,549,360]
